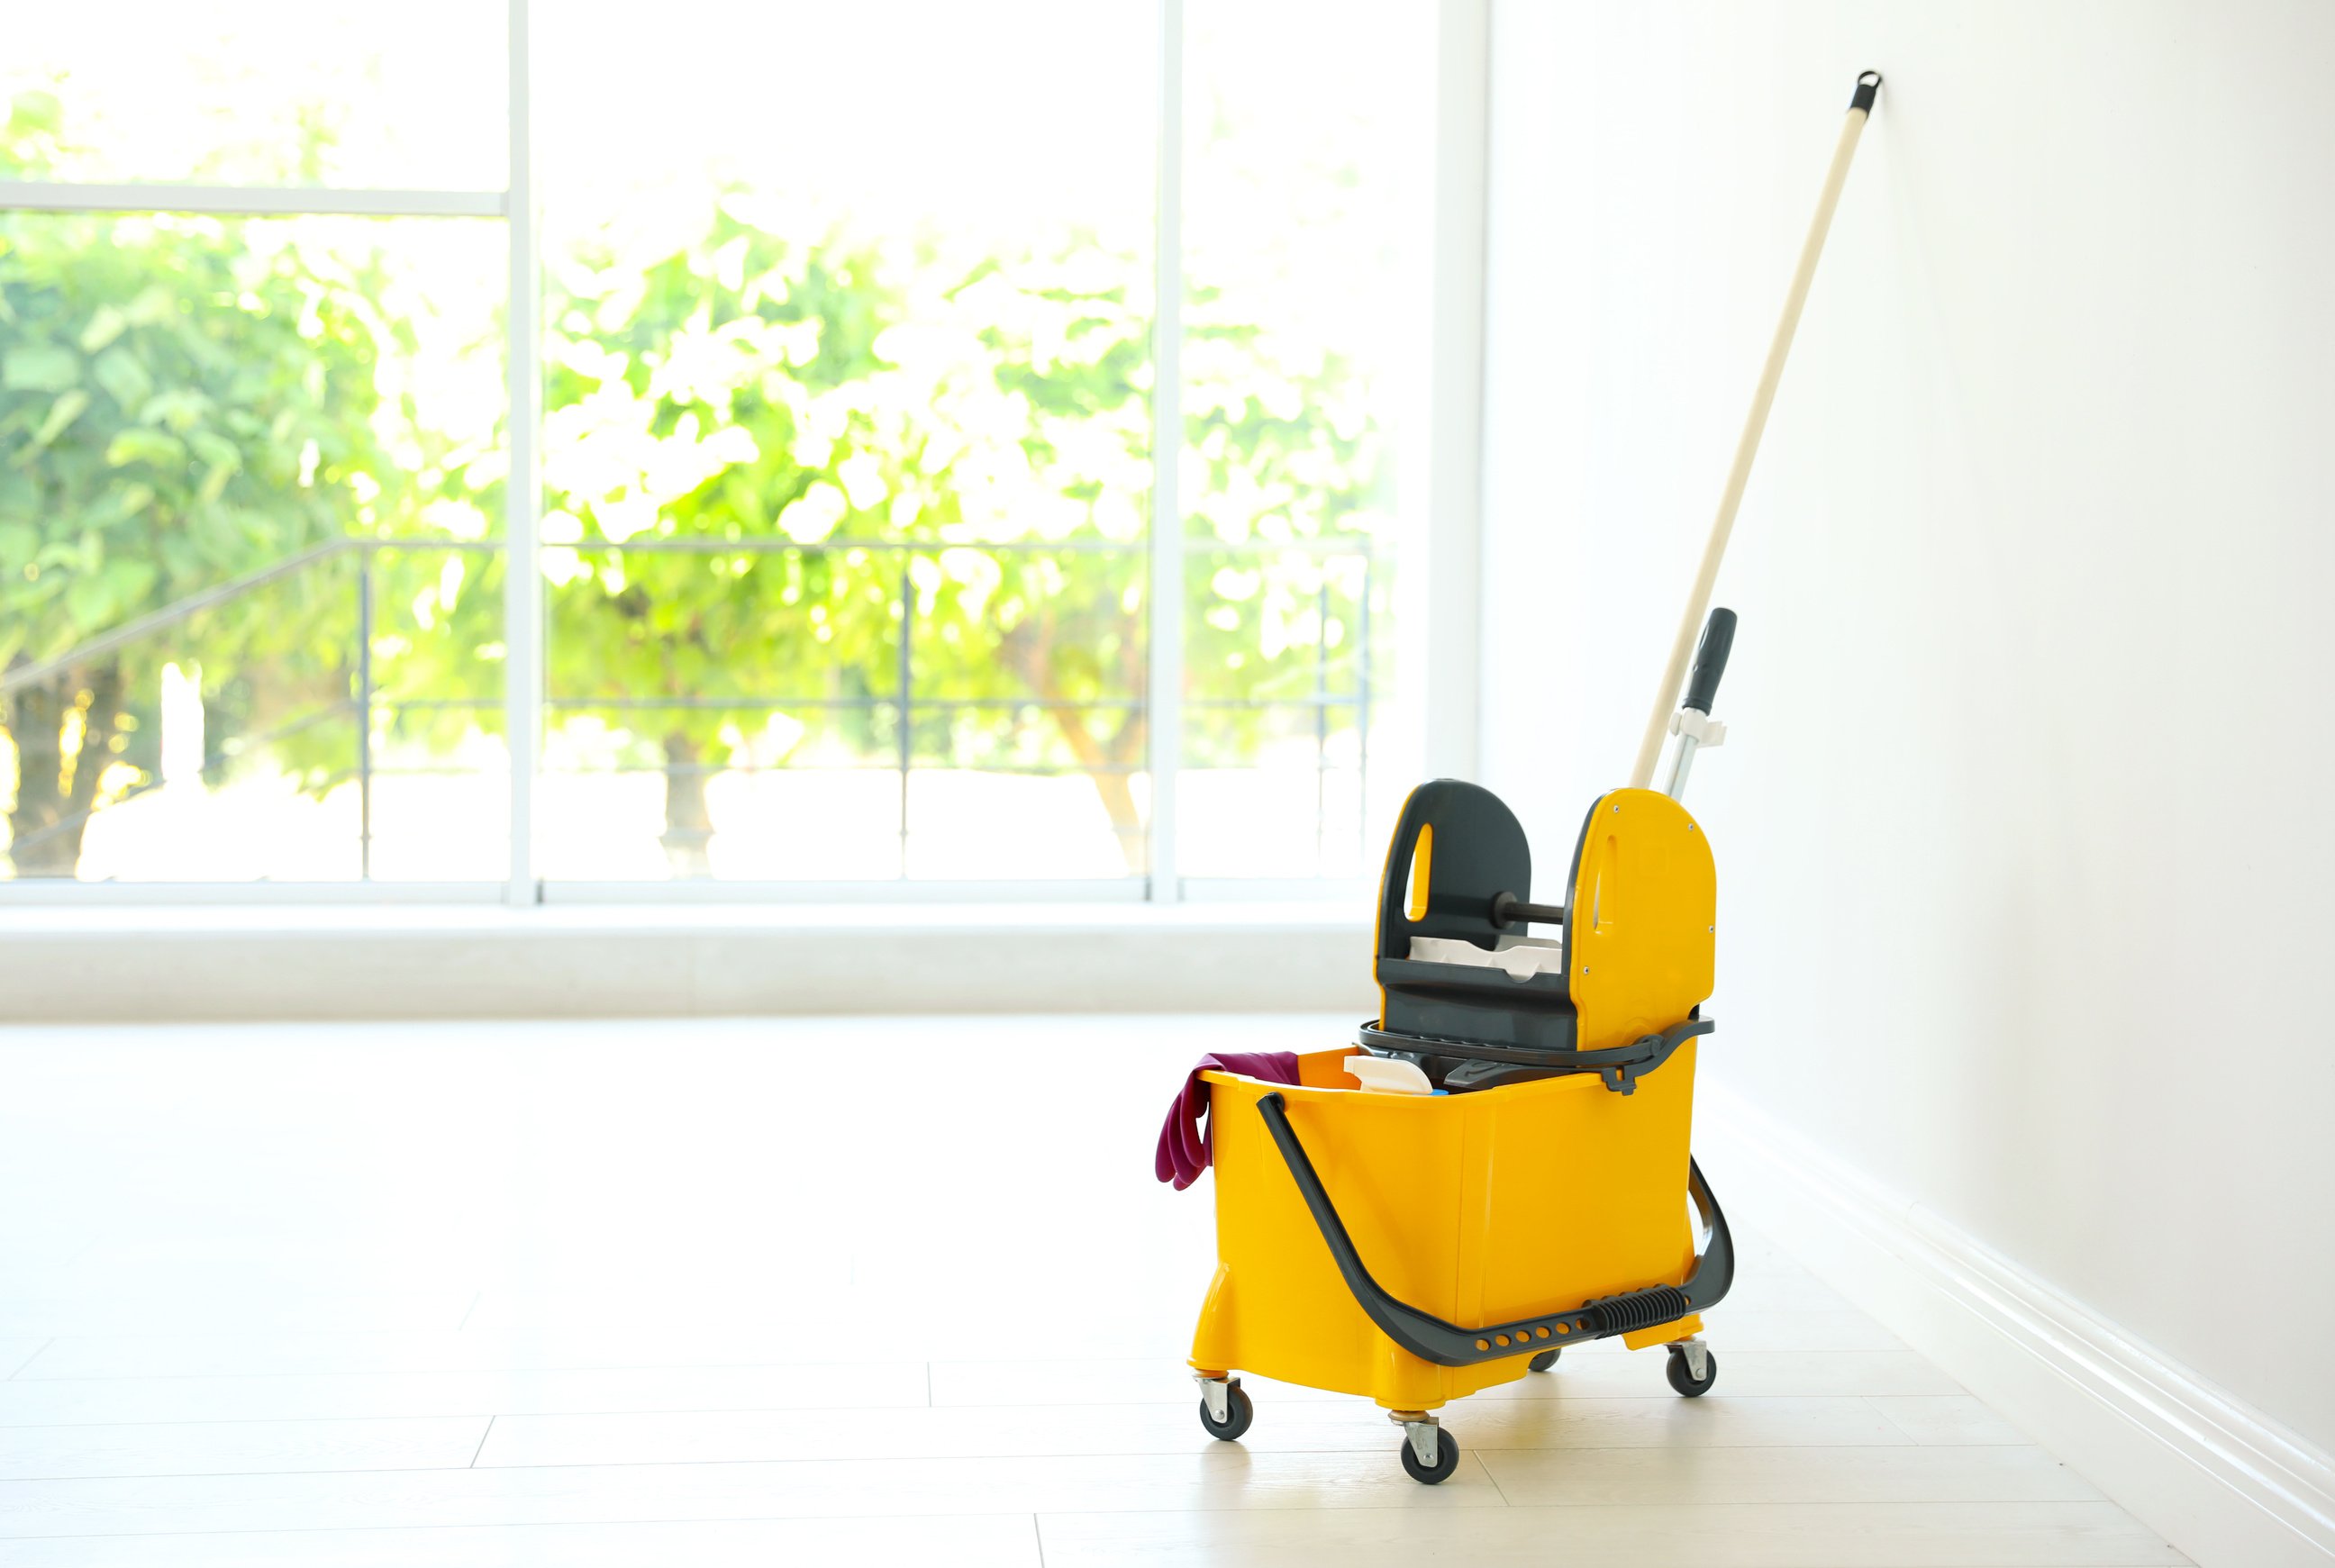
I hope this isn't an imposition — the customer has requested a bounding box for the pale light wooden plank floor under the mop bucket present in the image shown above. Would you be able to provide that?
[0,1020,2185,1568]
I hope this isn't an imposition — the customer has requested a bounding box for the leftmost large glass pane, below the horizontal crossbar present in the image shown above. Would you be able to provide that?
[0,213,504,880]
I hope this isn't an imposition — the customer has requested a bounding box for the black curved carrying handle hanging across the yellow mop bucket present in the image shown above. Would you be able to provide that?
[1256,1090,1735,1367]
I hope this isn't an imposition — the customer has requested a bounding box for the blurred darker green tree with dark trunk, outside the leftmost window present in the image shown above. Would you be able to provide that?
[0,94,399,877]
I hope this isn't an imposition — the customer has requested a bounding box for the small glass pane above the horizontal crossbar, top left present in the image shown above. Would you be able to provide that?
[0,0,509,189]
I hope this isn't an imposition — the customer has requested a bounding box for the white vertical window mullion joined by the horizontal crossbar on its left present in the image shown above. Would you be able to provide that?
[502,0,544,905]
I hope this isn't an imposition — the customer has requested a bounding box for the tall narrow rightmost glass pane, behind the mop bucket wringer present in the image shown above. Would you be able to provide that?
[1177,0,1433,875]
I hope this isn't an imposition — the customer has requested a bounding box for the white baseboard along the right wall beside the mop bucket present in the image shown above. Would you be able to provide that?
[1695,1087,2335,1568]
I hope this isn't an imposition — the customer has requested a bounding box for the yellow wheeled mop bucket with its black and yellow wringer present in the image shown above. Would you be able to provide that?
[1191,779,1732,1482]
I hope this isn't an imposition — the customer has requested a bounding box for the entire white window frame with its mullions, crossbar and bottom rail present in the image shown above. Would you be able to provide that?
[0,0,1490,908]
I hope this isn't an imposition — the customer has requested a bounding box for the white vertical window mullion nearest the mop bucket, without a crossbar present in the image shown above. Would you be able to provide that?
[1144,0,1184,903]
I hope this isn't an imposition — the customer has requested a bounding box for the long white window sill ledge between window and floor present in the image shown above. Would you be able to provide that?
[0,901,1376,1024]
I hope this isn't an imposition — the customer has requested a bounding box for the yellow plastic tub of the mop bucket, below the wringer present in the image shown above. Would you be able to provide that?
[1191,1046,1700,1409]
